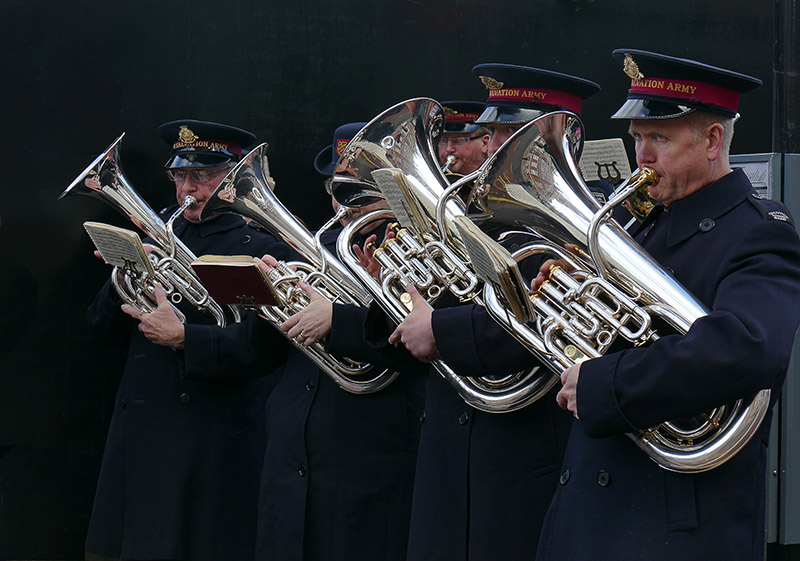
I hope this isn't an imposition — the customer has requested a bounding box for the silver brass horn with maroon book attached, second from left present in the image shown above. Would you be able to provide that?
[201,143,397,394]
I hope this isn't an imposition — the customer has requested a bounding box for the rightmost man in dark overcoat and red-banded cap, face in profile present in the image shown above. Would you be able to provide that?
[536,49,800,561]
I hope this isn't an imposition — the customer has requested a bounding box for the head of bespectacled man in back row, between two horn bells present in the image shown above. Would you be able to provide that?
[439,101,489,175]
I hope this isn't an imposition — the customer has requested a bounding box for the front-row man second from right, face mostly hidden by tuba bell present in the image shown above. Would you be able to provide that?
[375,64,599,561]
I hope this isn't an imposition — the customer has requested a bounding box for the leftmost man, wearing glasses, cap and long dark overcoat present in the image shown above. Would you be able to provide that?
[86,120,289,561]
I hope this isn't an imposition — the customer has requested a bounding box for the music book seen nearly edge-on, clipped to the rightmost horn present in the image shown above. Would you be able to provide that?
[454,216,534,323]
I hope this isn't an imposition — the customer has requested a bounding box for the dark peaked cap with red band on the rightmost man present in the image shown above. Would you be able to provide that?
[611,49,761,119]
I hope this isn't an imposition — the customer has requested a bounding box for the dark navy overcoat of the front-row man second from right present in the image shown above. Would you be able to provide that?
[366,232,572,561]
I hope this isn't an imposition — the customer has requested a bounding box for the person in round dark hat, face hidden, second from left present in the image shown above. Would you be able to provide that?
[256,123,424,561]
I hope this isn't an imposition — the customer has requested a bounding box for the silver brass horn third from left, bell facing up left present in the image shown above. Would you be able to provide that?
[333,98,555,413]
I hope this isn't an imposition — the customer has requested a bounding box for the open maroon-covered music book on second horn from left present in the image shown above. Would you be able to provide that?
[192,255,280,307]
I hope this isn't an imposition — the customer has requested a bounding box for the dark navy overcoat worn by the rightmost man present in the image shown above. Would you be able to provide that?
[537,170,800,561]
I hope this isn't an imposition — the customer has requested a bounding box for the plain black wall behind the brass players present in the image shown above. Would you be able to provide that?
[0,0,775,559]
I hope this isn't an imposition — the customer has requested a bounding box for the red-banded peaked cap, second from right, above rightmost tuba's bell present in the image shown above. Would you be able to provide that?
[472,63,600,125]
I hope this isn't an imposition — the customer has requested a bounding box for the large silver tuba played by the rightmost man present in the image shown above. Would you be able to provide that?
[468,112,770,472]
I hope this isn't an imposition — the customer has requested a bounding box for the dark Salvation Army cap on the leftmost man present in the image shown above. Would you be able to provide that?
[158,119,256,168]
